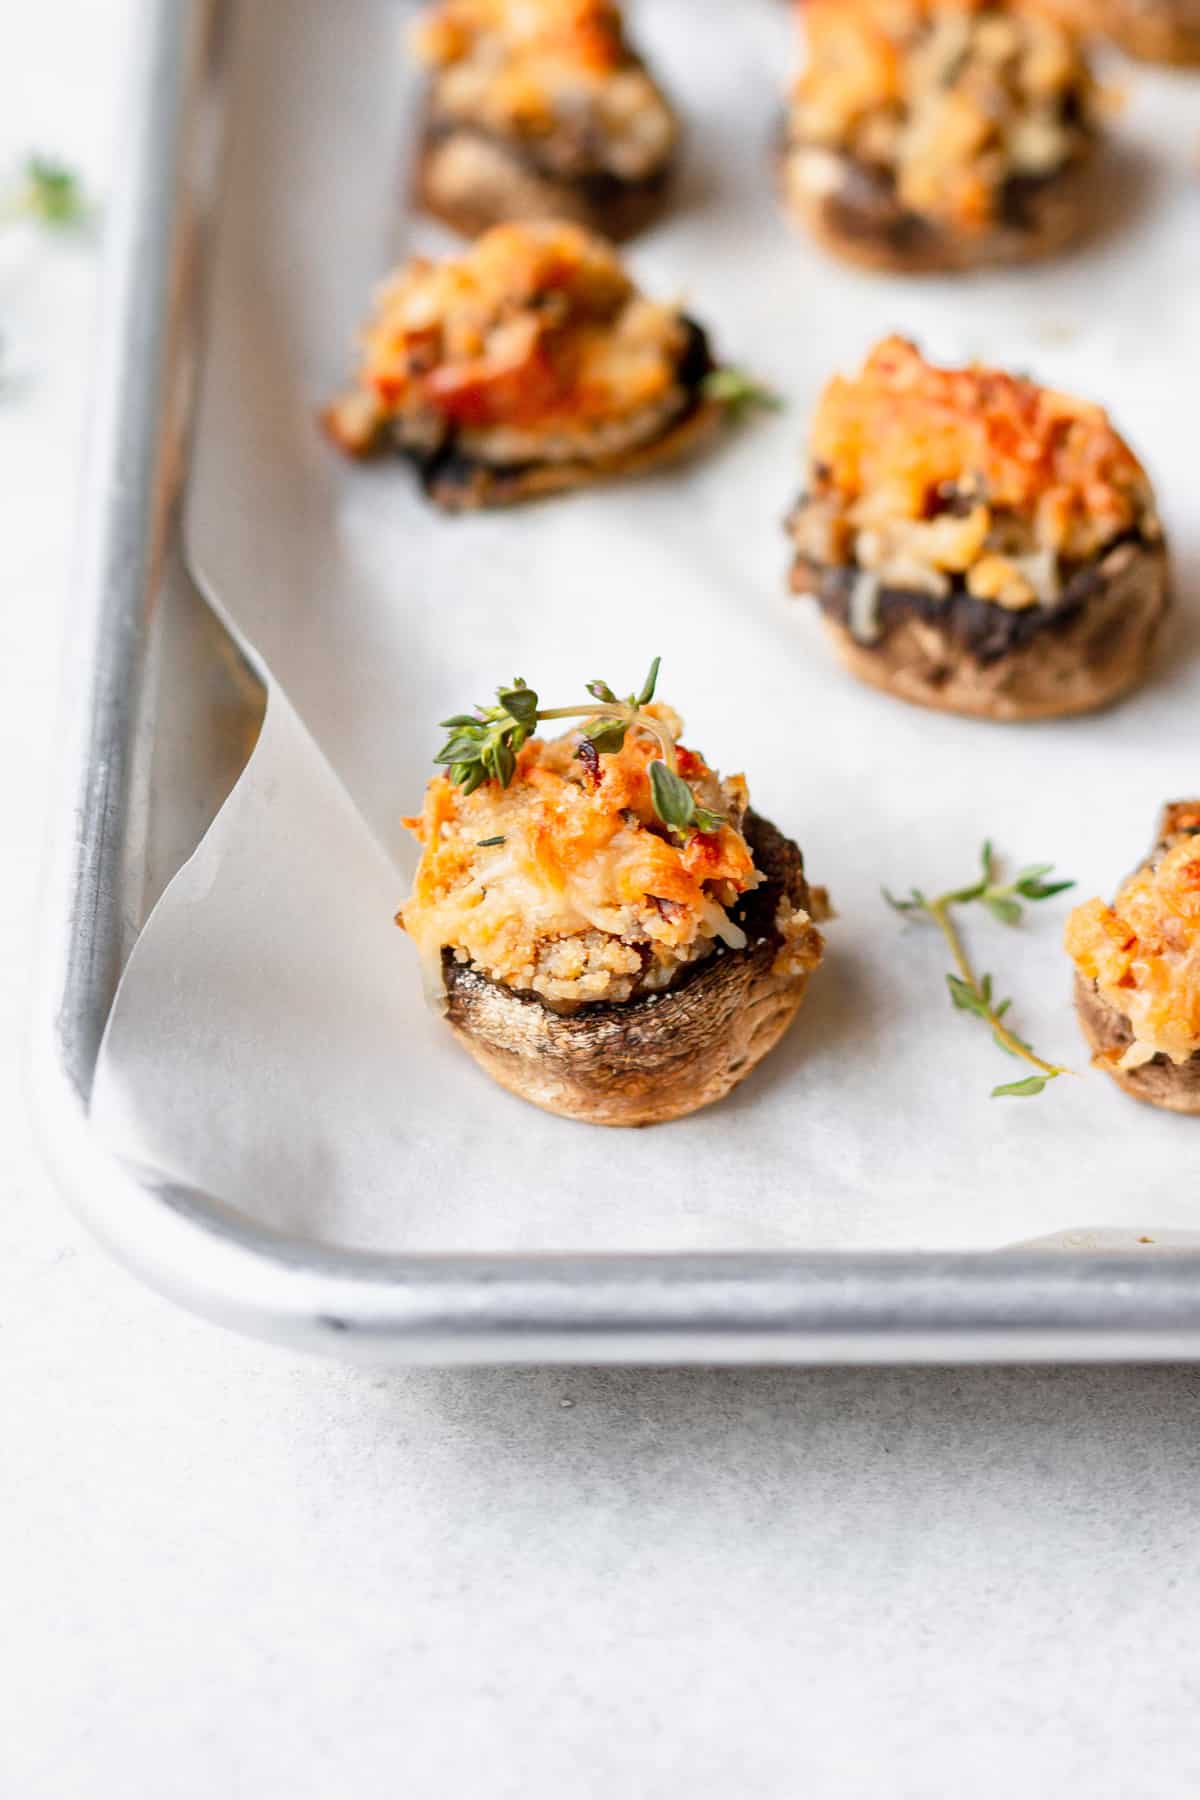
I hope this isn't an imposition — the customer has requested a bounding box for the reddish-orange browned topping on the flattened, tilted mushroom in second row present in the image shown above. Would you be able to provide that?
[327,223,687,461]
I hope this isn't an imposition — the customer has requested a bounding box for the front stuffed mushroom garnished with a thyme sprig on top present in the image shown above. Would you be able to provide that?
[398,664,826,1125]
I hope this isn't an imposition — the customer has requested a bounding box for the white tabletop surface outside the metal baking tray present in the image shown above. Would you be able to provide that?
[0,0,1200,1800]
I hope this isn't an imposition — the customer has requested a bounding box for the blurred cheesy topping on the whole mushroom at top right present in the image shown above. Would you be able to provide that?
[790,0,1092,232]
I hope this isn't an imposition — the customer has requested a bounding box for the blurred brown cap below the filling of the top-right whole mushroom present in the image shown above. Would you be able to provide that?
[786,151,1094,275]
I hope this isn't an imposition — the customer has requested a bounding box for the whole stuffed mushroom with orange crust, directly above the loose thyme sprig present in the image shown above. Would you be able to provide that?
[788,338,1168,720]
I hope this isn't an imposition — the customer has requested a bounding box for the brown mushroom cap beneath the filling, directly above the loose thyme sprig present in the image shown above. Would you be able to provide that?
[792,542,1168,720]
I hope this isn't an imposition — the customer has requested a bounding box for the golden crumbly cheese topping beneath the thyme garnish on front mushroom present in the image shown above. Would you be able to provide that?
[398,706,763,1010]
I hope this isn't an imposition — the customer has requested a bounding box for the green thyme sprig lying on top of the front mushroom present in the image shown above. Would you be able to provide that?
[434,657,725,837]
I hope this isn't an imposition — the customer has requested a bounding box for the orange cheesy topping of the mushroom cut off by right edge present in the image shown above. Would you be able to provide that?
[1067,817,1200,1069]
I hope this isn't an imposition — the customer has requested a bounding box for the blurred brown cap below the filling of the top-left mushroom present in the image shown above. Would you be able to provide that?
[416,122,671,243]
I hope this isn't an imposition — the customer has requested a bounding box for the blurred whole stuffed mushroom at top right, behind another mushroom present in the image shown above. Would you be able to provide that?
[783,0,1097,274]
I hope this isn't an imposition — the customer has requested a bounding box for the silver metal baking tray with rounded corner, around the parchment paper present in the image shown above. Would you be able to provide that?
[32,0,1200,1363]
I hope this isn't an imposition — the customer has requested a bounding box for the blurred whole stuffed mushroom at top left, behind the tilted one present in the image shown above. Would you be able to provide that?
[412,0,678,238]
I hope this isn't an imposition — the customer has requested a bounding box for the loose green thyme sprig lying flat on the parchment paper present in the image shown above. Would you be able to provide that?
[883,842,1074,1100]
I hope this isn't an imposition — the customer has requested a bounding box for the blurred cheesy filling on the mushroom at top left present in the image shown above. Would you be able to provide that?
[414,0,678,182]
